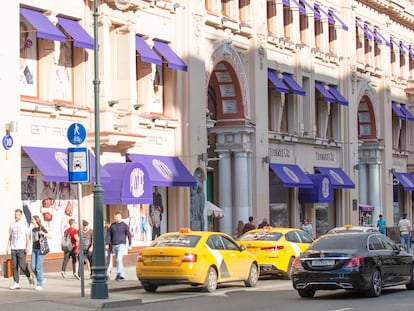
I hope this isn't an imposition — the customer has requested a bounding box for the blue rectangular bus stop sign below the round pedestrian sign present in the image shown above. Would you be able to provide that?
[68,148,89,182]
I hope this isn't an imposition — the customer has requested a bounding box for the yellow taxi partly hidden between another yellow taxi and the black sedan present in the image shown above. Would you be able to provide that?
[237,226,313,278]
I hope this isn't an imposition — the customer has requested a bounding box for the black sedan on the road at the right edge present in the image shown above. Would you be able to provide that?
[291,232,414,298]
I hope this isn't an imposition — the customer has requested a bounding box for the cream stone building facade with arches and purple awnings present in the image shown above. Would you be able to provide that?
[0,0,414,252]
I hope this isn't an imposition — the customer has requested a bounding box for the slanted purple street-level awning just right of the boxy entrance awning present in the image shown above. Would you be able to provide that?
[127,153,197,187]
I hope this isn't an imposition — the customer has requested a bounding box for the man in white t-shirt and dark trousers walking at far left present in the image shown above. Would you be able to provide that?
[7,208,34,290]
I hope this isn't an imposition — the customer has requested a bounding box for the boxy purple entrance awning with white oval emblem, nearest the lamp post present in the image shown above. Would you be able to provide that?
[102,162,152,205]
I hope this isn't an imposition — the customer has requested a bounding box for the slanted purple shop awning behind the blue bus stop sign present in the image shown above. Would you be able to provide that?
[22,146,110,182]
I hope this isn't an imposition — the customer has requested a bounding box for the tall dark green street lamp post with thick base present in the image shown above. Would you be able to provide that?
[91,0,108,299]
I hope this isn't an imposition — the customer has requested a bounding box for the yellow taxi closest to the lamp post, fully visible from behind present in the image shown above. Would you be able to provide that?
[136,228,259,292]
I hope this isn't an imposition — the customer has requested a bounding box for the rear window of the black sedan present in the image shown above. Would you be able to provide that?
[309,234,367,250]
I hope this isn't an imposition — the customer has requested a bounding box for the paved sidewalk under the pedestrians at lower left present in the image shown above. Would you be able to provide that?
[0,266,141,310]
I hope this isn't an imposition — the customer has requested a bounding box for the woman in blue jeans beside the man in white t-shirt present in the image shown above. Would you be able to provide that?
[30,215,52,290]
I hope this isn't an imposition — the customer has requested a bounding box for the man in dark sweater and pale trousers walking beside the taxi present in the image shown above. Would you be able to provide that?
[105,211,132,281]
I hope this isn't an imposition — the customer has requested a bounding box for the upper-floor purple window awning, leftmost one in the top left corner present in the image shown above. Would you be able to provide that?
[20,8,66,42]
